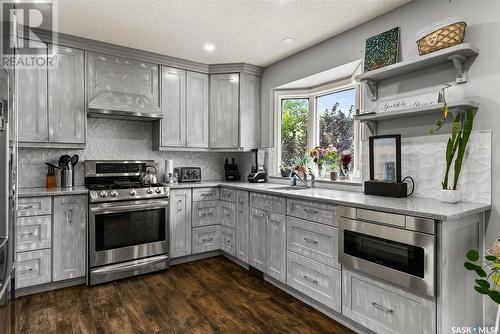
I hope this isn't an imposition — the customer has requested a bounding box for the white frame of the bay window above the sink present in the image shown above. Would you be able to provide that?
[271,78,362,182]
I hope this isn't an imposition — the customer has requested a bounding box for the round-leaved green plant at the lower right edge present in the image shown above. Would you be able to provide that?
[464,245,500,333]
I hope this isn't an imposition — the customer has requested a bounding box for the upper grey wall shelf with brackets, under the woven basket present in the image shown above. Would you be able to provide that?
[354,43,479,101]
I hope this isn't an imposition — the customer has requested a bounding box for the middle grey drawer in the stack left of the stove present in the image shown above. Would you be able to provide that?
[16,216,52,252]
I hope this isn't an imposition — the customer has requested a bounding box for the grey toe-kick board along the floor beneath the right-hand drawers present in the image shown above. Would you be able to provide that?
[264,274,376,334]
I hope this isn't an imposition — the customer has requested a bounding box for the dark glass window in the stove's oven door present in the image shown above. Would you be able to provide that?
[95,209,166,251]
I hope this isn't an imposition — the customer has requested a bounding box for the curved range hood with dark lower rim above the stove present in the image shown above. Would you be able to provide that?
[87,91,163,121]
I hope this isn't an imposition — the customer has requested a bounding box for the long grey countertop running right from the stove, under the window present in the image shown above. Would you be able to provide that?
[169,181,491,220]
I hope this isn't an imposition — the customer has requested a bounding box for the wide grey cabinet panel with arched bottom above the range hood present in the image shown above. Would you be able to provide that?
[88,52,160,107]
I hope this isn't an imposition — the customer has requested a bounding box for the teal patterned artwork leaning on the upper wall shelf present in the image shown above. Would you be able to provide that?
[364,27,399,72]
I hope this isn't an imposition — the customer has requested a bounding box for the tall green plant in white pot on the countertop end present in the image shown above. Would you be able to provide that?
[429,89,474,203]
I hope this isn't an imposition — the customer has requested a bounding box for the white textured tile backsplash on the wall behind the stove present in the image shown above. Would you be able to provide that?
[19,118,253,187]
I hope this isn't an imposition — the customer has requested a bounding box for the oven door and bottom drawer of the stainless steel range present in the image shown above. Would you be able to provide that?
[89,198,169,285]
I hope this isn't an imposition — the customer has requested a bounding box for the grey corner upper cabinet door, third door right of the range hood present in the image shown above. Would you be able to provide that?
[210,73,239,148]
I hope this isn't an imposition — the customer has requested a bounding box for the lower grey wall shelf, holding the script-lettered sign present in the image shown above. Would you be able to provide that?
[355,100,479,135]
